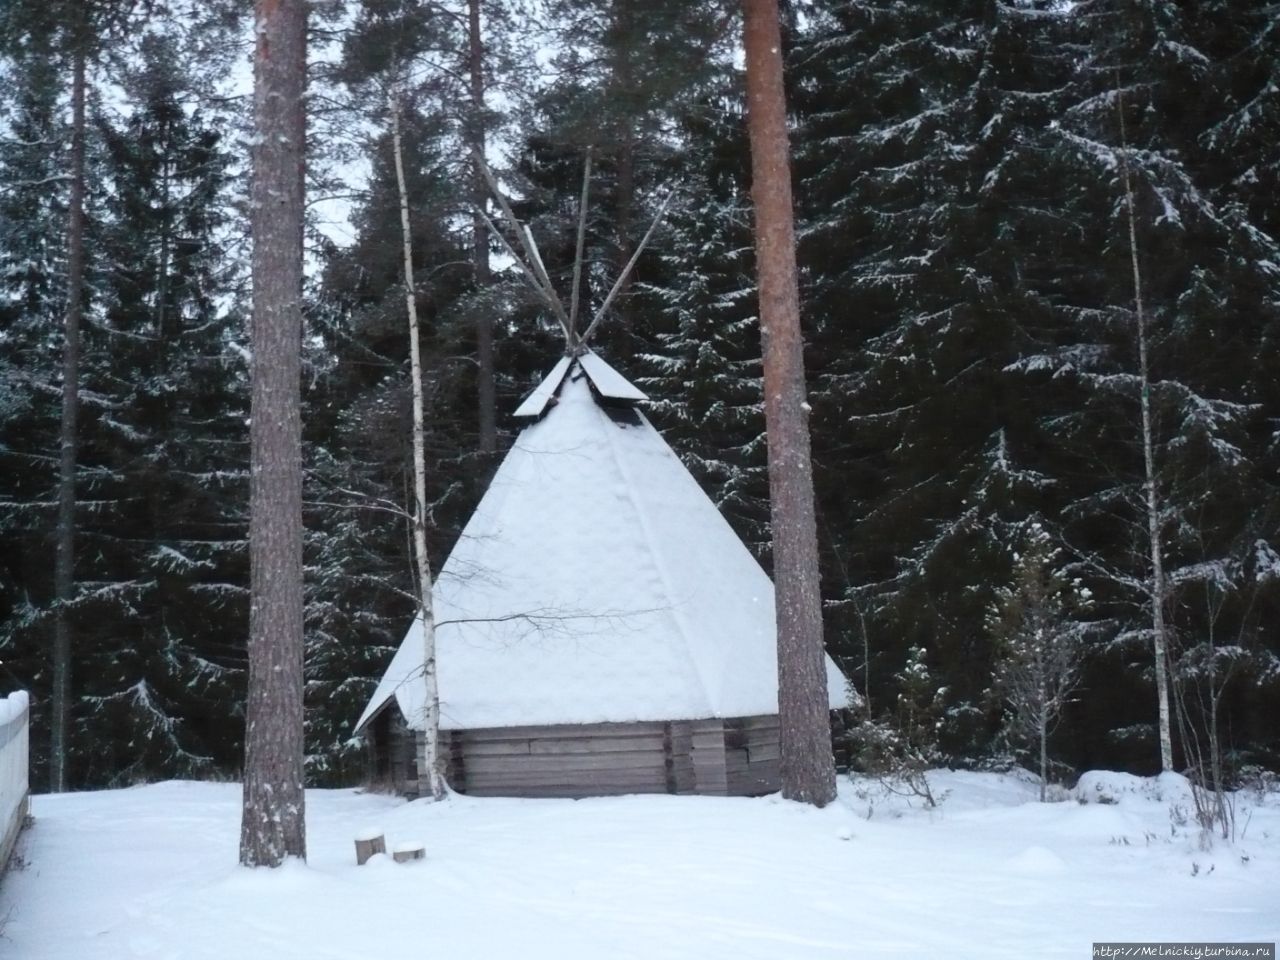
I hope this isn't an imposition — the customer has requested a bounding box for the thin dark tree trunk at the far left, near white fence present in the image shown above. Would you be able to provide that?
[49,39,86,794]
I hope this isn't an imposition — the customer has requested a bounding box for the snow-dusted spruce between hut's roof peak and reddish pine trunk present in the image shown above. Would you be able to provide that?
[632,92,769,559]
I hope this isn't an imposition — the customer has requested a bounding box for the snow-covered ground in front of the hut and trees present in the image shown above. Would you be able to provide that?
[0,773,1280,960]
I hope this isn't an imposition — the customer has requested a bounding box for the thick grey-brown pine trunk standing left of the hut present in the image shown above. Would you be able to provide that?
[239,0,306,867]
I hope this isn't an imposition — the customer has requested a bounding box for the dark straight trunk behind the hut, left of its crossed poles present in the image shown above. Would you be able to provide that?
[467,0,498,453]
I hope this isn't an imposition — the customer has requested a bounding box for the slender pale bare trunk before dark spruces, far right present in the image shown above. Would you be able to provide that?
[1116,97,1174,771]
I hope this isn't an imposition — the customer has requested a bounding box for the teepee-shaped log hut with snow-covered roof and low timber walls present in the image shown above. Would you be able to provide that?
[357,160,846,796]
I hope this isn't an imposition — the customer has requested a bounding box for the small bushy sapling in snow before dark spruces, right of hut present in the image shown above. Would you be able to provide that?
[987,522,1089,800]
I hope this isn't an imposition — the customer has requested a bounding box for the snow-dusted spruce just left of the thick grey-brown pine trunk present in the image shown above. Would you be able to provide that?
[81,31,247,778]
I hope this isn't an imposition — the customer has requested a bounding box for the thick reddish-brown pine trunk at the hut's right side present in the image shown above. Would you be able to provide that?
[744,0,836,806]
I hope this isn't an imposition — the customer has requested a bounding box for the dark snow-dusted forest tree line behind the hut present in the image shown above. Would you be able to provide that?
[0,0,1280,785]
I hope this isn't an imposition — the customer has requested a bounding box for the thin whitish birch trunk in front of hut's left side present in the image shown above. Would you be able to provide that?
[390,88,444,800]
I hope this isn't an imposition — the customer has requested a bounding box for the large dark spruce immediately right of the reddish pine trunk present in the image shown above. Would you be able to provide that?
[794,0,1069,721]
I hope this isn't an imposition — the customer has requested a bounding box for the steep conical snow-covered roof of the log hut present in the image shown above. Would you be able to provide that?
[357,352,846,730]
